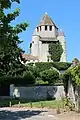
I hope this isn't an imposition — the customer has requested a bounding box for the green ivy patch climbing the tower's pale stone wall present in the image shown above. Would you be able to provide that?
[49,42,63,62]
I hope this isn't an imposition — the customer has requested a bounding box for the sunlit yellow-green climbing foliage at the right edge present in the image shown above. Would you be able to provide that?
[63,62,80,95]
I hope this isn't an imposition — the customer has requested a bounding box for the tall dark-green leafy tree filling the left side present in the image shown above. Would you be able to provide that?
[0,0,28,76]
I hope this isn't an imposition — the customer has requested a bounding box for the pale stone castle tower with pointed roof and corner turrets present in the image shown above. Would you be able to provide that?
[30,13,66,62]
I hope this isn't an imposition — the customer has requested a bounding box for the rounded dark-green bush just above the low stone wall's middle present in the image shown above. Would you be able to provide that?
[40,69,59,84]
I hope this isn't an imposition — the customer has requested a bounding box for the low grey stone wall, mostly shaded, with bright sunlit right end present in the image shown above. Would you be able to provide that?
[10,85,65,100]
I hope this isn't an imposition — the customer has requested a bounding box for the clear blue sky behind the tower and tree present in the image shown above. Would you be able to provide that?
[5,0,80,62]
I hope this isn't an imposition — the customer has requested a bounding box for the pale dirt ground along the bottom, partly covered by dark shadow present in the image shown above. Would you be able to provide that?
[0,108,80,120]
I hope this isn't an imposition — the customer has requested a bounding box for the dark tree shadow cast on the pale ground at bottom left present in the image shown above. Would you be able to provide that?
[0,110,47,120]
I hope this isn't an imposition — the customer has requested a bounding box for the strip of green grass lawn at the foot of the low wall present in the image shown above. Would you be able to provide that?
[0,100,64,109]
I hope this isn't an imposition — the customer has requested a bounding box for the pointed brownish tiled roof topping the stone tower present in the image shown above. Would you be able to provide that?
[38,12,57,28]
